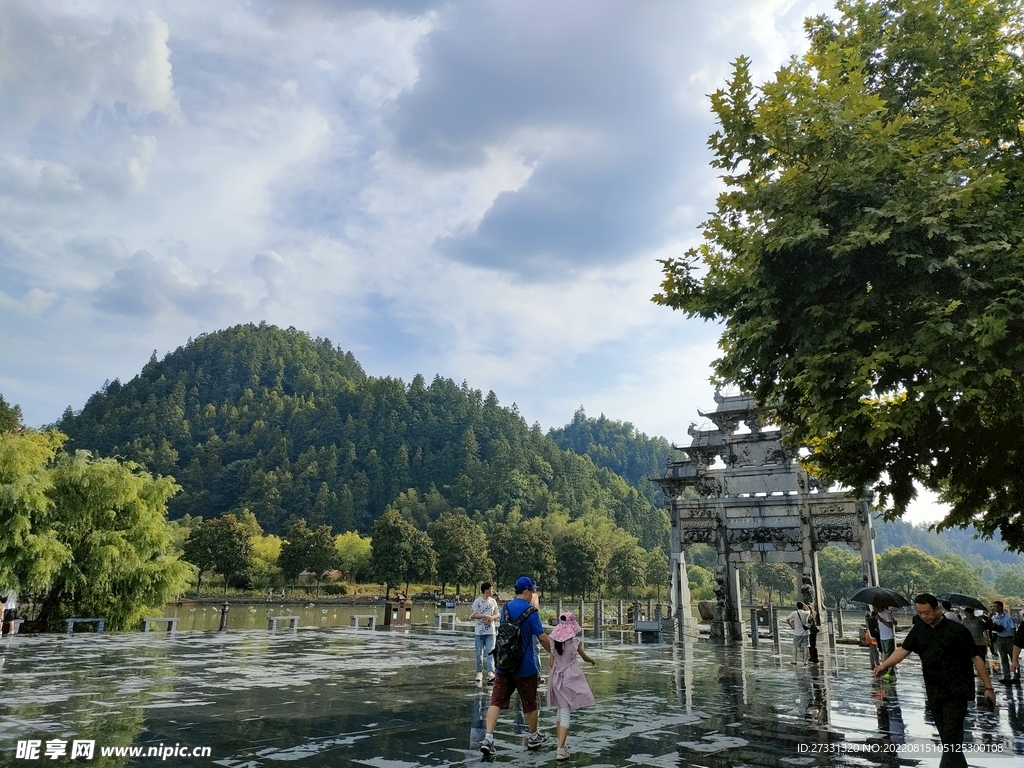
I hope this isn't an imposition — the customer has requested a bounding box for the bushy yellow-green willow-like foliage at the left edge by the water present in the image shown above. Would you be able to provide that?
[0,430,188,631]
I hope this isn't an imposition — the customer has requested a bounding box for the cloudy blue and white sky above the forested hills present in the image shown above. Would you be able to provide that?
[0,0,935,519]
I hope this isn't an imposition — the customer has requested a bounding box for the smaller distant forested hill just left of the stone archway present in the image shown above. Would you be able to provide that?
[548,406,675,507]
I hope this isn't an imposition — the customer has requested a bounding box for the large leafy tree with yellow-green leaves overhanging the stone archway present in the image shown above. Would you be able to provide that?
[655,0,1024,550]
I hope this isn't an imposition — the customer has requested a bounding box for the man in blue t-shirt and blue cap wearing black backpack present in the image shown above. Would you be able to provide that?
[480,577,551,755]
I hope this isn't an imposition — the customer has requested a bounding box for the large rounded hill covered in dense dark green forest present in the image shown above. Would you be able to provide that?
[56,324,668,549]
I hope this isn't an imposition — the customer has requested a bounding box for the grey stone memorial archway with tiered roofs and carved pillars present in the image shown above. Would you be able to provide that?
[657,392,878,641]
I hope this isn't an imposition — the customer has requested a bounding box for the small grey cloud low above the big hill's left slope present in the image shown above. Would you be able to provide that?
[92,251,241,319]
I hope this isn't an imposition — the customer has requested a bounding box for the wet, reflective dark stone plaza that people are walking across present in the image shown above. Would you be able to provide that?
[0,628,1024,768]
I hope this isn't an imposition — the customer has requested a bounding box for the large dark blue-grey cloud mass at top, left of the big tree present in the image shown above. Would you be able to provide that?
[389,2,711,279]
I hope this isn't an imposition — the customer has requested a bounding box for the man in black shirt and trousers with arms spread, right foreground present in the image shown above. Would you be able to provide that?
[874,593,995,768]
